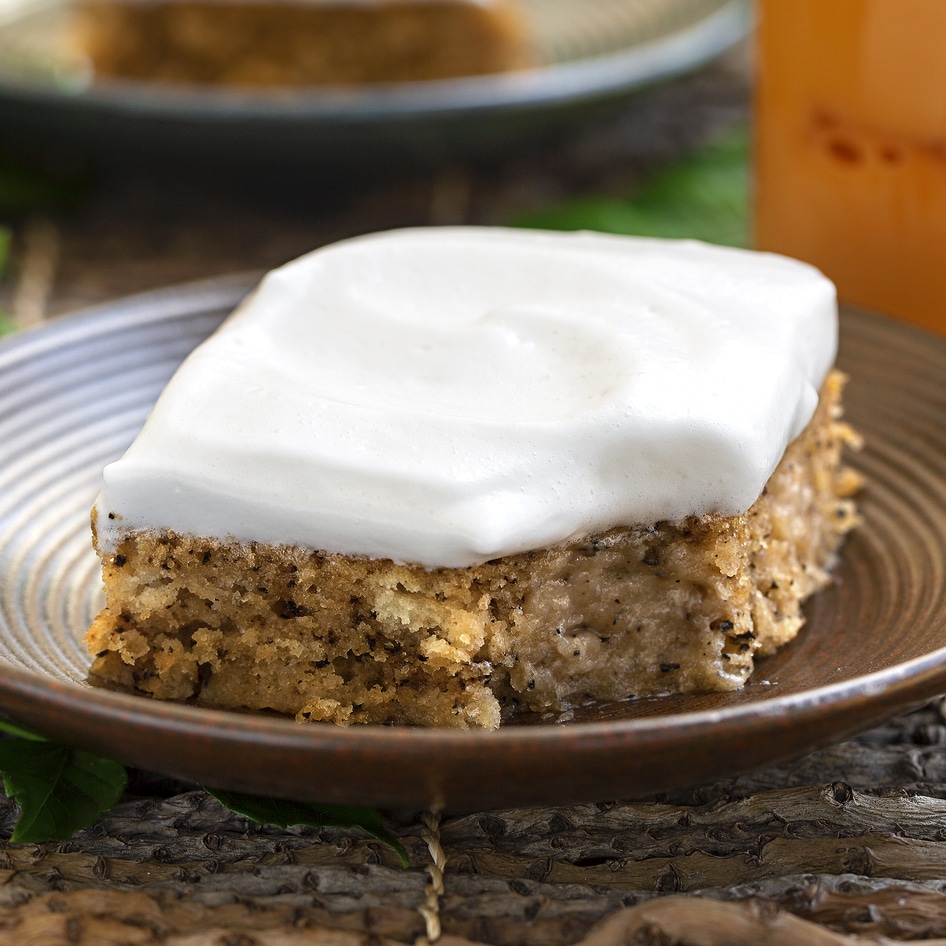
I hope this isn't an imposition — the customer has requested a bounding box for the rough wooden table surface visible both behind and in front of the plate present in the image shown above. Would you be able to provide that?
[0,51,946,946]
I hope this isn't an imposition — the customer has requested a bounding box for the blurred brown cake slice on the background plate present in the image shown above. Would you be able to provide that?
[75,0,534,88]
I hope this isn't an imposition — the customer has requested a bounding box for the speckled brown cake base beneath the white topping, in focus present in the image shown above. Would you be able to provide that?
[86,372,859,729]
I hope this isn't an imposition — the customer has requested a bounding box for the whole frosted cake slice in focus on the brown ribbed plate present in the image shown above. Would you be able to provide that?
[87,228,857,728]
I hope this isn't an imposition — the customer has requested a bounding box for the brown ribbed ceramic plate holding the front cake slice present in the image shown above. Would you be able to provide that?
[0,279,946,809]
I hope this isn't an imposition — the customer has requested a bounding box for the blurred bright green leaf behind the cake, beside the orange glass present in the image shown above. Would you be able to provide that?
[513,127,749,246]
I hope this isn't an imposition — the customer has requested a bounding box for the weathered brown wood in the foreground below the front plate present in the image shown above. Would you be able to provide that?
[0,707,946,946]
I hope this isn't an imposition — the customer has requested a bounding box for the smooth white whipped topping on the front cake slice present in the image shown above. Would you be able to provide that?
[96,228,837,567]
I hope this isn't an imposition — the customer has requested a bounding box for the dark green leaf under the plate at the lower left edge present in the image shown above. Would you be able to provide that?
[0,736,128,843]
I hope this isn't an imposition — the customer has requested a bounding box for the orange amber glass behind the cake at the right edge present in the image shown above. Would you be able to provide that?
[755,0,946,334]
